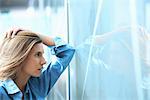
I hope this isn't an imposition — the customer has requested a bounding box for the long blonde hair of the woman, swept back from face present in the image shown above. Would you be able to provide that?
[0,31,42,81]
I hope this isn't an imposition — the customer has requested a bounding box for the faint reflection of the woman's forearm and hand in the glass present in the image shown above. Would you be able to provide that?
[85,26,150,45]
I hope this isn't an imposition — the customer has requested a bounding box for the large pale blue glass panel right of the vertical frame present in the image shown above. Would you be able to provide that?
[69,0,150,100]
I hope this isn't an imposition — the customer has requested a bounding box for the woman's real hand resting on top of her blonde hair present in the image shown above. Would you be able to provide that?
[5,28,23,38]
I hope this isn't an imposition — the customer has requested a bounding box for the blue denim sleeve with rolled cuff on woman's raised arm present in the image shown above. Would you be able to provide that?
[30,37,75,96]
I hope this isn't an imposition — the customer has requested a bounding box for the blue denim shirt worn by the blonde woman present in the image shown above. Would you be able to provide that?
[0,38,75,100]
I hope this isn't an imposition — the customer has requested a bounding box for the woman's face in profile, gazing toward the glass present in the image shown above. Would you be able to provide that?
[21,43,46,77]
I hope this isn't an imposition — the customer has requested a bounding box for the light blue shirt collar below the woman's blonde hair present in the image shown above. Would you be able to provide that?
[3,79,20,94]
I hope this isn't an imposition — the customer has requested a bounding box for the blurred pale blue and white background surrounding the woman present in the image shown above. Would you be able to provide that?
[0,0,150,100]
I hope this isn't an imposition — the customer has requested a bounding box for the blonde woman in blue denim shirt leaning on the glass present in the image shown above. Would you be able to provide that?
[0,30,75,100]
